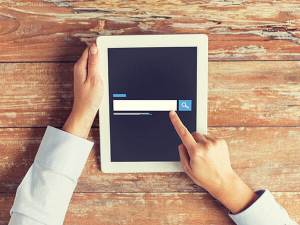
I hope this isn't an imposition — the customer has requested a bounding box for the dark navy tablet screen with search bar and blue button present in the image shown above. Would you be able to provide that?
[108,47,197,162]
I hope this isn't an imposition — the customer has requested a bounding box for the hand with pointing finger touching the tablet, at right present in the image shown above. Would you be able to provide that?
[170,111,256,213]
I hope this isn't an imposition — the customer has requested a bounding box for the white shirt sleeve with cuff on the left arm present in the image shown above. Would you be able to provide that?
[9,126,93,225]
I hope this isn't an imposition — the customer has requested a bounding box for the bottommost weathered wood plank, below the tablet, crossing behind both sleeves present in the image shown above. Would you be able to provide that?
[0,192,300,225]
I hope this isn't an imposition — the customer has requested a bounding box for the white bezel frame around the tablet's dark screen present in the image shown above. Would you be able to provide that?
[96,34,208,173]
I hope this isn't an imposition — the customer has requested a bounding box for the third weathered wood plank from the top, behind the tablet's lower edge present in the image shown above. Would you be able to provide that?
[0,127,300,192]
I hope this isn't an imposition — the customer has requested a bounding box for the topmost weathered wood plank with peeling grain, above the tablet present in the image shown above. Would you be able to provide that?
[0,0,300,62]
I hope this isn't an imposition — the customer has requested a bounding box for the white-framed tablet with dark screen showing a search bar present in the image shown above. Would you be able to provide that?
[97,34,208,173]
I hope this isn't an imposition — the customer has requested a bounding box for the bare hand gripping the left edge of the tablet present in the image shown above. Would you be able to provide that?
[63,44,103,138]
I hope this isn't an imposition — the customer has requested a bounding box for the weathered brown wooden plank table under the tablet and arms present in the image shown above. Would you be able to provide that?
[0,0,300,225]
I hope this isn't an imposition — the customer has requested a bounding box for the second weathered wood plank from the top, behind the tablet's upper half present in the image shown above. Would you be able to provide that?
[0,61,300,127]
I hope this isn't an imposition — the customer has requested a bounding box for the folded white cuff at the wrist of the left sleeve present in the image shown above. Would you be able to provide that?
[34,126,94,181]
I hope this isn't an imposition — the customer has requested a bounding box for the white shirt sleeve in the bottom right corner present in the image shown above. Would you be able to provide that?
[229,190,297,225]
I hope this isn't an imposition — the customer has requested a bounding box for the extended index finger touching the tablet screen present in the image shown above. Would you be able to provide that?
[169,111,197,150]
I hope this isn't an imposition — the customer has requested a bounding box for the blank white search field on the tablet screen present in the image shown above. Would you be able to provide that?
[113,100,177,111]
